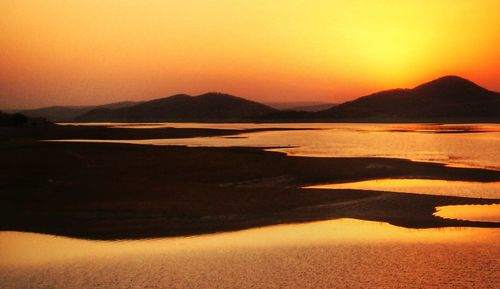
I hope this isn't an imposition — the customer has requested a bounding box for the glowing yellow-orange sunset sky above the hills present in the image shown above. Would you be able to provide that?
[0,0,500,108]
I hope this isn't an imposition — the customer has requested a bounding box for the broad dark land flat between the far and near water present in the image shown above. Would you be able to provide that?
[0,124,500,239]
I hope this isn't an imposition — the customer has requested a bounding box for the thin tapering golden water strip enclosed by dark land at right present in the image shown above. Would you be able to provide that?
[306,179,500,199]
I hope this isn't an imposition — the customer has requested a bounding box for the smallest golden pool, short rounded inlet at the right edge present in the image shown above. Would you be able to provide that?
[434,204,500,222]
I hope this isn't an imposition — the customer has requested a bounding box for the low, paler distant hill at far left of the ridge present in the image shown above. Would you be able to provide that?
[19,101,138,122]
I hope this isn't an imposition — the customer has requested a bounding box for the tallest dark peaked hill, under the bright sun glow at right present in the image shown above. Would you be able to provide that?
[315,76,500,121]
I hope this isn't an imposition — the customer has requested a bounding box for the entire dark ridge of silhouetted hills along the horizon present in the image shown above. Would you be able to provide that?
[12,75,500,122]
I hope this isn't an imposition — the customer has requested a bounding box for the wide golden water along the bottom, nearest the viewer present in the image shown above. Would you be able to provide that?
[0,219,500,288]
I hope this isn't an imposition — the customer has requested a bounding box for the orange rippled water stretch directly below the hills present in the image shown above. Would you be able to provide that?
[56,123,500,170]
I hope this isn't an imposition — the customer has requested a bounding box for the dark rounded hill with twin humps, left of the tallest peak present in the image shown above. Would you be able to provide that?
[75,92,276,122]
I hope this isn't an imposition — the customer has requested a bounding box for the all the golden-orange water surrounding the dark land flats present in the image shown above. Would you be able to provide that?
[0,123,500,289]
